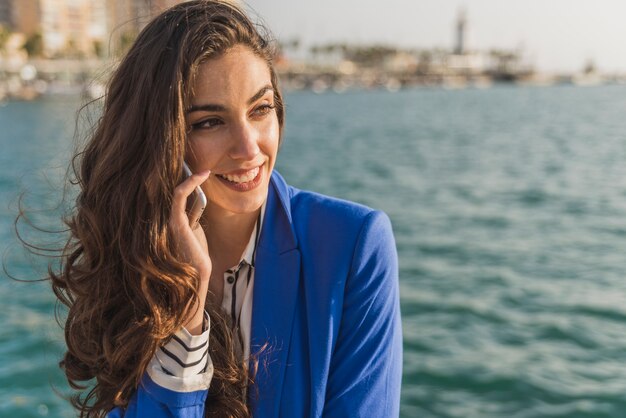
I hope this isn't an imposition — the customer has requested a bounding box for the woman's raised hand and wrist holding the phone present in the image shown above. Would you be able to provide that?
[169,170,213,335]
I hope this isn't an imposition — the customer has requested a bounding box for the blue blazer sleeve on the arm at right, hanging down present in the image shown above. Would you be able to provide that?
[323,211,402,418]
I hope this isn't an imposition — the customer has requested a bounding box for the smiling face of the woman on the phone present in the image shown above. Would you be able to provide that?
[186,45,280,216]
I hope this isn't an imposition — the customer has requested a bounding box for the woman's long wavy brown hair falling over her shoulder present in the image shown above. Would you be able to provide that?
[49,0,284,417]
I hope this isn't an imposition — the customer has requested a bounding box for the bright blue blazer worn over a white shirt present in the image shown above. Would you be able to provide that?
[110,172,402,418]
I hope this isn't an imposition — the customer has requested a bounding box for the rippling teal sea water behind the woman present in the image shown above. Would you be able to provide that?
[0,86,626,418]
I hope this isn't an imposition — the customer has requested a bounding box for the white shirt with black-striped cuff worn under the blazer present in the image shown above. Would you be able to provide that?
[148,204,265,392]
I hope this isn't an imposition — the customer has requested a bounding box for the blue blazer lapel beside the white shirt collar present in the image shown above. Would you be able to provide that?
[248,173,300,417]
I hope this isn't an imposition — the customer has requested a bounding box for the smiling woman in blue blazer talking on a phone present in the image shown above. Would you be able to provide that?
[51,0,402,417]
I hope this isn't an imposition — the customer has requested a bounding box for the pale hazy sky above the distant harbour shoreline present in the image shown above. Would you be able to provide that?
[246,0,626,73]
